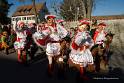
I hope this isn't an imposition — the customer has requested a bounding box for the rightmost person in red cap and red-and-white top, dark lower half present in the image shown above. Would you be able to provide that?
[91,22,107,72]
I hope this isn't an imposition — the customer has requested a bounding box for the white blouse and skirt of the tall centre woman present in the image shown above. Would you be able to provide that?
[46,24,68,56]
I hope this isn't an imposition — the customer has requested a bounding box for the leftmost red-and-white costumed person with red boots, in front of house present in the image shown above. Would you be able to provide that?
[14,21,27,62]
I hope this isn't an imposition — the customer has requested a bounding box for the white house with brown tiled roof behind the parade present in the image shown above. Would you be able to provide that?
[11,3,49,27]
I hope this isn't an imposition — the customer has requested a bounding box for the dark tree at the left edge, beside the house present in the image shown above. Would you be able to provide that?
[0,0,13,24]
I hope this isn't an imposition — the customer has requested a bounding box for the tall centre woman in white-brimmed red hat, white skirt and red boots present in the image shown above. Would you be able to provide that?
[45,15,67,74]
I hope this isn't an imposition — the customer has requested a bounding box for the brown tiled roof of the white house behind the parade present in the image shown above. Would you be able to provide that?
[12,3,44,17]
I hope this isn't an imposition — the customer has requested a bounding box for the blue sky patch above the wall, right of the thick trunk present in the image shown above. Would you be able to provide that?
[92,0,124,16]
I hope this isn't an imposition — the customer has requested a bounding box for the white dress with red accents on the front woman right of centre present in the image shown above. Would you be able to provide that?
[70,31,94,67]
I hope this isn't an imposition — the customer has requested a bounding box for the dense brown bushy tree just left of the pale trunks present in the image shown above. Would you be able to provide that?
[60,0,82,20]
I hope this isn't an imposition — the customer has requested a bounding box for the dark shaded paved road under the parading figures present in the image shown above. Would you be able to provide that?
[0,48,124,83]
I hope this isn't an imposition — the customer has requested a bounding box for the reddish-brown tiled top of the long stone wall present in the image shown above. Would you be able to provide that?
[92,15,124,20]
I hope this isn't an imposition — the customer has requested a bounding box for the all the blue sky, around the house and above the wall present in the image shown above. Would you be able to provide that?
[8,0,124,16]
